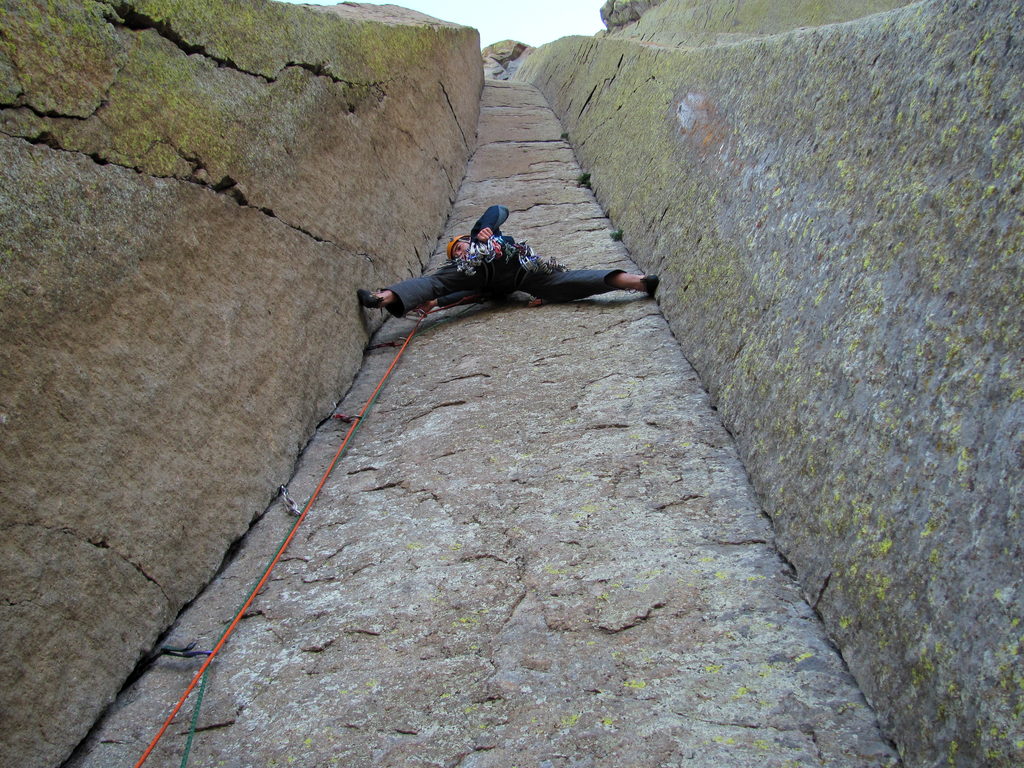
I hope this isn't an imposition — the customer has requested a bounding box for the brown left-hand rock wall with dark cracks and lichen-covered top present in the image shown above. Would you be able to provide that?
[0,0,482,766]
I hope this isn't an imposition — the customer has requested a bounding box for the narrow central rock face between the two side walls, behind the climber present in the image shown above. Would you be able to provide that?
[69,83,895,768]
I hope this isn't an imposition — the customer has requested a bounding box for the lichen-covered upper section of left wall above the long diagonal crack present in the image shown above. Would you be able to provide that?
[0,0,475,249]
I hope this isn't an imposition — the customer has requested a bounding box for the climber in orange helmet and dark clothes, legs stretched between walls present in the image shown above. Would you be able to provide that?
[356,206,658,317]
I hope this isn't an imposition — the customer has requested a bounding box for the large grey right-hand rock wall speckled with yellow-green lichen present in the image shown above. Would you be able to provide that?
[520,1,1024,768]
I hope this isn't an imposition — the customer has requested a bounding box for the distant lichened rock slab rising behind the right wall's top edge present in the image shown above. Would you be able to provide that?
[601,0,910,46]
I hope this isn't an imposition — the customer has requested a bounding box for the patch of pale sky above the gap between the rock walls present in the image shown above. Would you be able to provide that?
[282,0,604,47]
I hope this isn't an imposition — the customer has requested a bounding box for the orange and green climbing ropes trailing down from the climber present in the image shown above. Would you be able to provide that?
[134,297,475,768]
